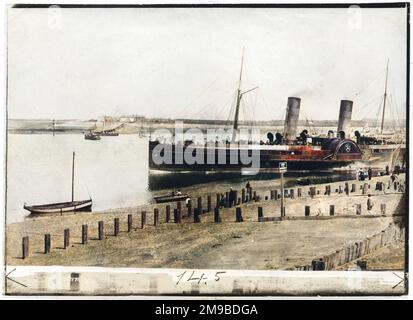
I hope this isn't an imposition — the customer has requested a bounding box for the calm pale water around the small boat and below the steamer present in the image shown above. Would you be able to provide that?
[7,134,354,223]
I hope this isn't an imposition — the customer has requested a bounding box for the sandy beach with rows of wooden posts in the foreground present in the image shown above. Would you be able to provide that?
[7,175,404,269]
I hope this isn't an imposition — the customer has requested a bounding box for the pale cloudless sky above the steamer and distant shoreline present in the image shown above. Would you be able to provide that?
[7,8,407,120]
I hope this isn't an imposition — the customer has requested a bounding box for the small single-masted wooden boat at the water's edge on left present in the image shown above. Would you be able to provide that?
[23,152,92,215]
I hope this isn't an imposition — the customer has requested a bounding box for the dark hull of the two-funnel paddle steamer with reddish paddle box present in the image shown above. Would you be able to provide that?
[149,139,363,174]
